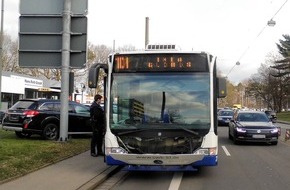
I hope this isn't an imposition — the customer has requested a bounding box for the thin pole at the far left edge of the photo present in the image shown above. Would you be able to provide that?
[0,0,4,109]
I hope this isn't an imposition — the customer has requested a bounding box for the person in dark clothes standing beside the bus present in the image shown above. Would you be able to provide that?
[90,94,105,157]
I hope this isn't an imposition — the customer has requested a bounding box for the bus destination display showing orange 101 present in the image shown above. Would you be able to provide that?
[113,54,208,72]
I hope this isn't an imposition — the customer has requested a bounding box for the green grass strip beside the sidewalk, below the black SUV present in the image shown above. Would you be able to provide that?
[0,129,90,182]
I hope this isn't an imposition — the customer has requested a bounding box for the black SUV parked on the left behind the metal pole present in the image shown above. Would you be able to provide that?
[2,99,92,140]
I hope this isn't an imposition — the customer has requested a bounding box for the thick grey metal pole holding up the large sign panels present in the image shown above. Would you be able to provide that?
[59,0,71,141]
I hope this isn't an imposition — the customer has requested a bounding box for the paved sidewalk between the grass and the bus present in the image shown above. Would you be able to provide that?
[0,151,118,190]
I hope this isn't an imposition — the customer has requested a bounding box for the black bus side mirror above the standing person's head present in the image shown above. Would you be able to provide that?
[88,63,108,88]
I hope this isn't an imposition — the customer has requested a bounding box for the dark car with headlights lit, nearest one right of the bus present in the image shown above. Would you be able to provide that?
[228,111,279,145]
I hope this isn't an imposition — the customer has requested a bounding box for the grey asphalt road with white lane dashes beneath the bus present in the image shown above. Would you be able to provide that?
[105,124,290,190]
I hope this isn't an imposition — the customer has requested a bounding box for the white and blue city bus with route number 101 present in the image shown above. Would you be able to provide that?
[88,45,226,171]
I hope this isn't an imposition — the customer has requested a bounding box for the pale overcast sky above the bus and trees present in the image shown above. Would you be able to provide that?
[4,0,290,84]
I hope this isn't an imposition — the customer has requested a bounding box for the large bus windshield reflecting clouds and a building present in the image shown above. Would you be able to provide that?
[110,72,210,132]
